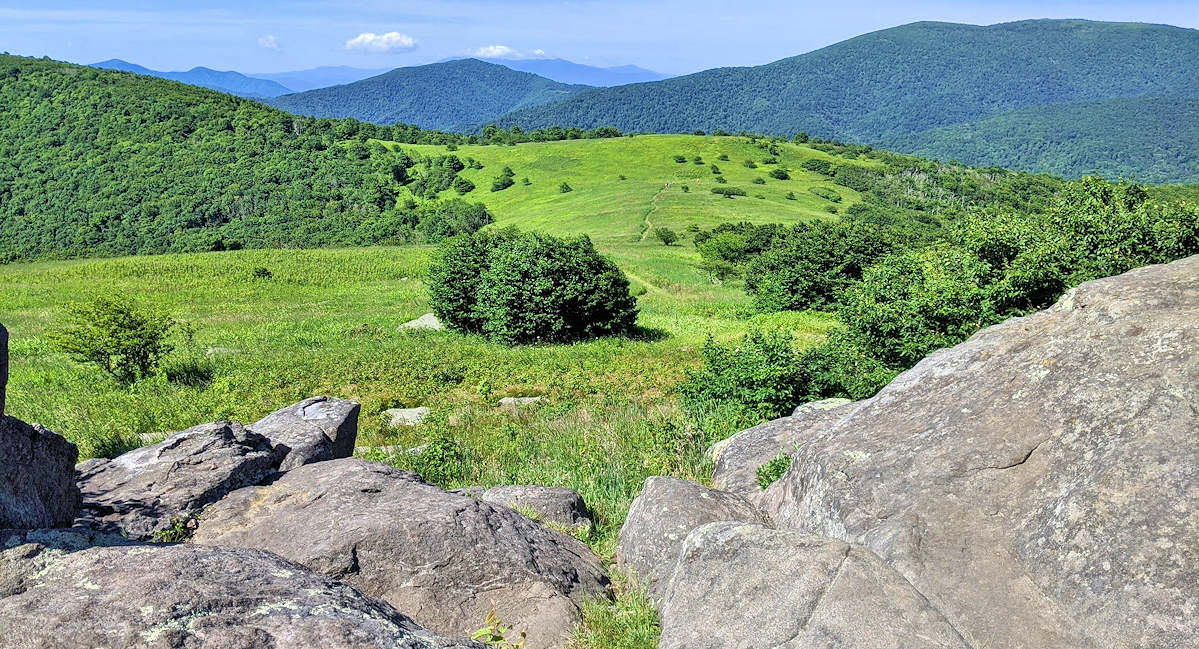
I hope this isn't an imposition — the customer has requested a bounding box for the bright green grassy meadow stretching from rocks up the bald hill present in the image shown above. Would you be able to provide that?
[0,136,851,554]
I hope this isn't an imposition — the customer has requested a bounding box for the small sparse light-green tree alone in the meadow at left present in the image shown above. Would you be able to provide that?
[48,295,179,384]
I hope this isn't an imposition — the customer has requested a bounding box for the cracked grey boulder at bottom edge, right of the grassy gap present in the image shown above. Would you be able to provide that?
[658,522,971,649]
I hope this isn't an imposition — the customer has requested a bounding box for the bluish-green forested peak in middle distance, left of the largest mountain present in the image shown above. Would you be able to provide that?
[265,59,592,132]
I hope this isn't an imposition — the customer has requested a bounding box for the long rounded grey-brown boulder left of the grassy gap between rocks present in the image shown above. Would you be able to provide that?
[193,458,608,649]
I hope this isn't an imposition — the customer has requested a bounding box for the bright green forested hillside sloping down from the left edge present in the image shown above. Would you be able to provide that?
[0,55,486,260]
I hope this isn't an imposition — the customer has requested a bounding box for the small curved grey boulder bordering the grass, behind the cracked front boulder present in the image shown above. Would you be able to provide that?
[616,476,766,600]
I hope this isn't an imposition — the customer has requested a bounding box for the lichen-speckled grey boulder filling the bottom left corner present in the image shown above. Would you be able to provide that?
[0,533,482,649]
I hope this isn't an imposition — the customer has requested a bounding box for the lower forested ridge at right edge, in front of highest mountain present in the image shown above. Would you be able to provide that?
[885,97,1199,182]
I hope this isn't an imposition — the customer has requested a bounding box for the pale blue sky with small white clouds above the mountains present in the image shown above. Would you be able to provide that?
[0,0,1199,73]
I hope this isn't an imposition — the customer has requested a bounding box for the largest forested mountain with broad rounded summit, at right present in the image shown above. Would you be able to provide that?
[500,20,1199,182]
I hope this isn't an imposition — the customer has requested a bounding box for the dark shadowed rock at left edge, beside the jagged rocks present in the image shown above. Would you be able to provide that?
[0,416,79,529]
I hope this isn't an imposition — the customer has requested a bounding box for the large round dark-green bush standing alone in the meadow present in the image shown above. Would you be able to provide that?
[429,229,637,344]
